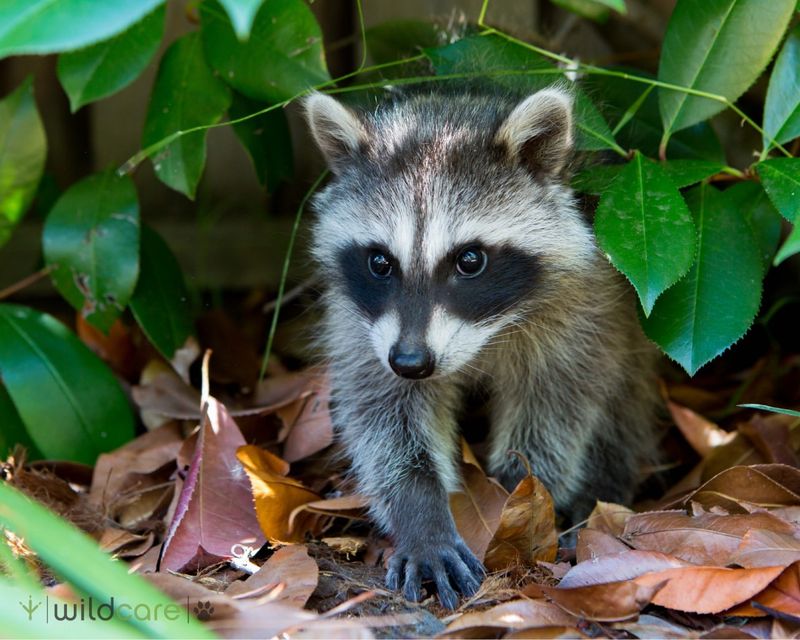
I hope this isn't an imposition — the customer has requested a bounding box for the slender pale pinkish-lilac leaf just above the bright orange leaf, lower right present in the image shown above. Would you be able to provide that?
[558,549,690,589]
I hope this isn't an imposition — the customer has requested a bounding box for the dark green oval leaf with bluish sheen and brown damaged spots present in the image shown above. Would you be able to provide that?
[42,170,139,331]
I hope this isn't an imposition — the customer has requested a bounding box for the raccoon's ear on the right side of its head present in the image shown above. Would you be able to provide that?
[495,88,573,179]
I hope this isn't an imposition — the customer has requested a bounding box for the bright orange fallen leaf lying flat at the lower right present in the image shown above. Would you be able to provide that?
[634,567,783,613]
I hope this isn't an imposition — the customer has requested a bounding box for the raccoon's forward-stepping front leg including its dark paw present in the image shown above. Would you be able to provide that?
[334,376,484,609]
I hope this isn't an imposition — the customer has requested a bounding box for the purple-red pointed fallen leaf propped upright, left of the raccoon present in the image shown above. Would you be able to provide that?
[161,397,264,571]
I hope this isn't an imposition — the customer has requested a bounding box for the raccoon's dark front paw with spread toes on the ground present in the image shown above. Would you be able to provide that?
[386,539,486,609]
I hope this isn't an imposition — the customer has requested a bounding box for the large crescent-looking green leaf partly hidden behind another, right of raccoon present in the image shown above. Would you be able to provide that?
[642,185,762,375]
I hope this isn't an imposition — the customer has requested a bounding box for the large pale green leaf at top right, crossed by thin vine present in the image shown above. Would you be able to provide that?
[658,0,795,136]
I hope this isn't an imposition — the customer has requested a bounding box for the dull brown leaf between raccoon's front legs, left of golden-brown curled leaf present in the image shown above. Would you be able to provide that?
[450,464,508,561]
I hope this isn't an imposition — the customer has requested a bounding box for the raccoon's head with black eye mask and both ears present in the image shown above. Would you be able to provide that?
[307,90,593,379]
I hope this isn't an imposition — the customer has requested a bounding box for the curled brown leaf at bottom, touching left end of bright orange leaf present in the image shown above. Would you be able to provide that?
[541,574,662,622]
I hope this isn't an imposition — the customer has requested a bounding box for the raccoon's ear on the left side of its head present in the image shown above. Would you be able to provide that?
[304,93,367,173]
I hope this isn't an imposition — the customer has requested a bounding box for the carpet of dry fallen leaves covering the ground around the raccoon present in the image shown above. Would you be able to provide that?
[4,313,800,638]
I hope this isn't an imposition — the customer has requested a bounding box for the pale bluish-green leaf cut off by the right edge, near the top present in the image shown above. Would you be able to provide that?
[764,25,800,149]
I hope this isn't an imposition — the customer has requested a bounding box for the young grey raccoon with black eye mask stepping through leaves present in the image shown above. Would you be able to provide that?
[305,87,657,608]
